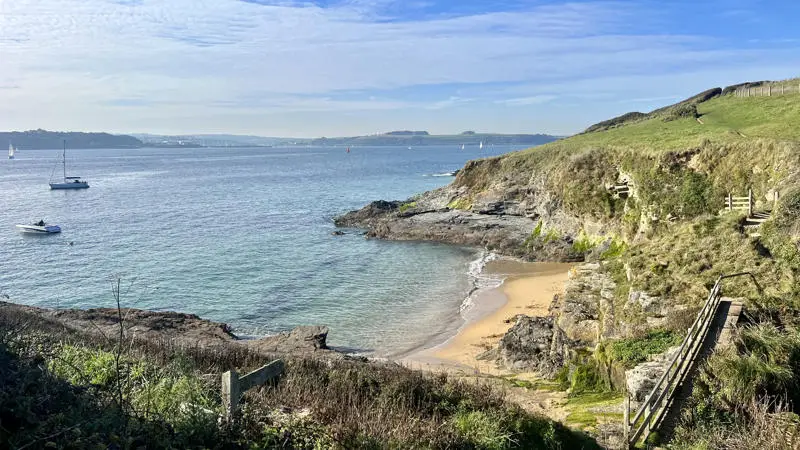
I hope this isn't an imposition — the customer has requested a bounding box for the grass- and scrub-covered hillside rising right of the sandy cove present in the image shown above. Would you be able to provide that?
[452,80,800,449]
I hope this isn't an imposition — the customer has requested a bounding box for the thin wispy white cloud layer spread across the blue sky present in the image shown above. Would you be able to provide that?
[0,0,798,134]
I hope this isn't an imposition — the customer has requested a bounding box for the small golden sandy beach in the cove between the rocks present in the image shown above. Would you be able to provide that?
[405,260,572,374]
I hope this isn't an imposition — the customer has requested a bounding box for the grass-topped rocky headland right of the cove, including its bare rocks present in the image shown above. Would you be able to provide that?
[336,80,800,448]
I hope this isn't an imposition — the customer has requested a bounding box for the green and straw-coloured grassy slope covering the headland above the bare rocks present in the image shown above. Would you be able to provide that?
[456,85,800,448]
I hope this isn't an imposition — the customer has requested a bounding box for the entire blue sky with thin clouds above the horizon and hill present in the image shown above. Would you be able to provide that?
[0,0,800,137]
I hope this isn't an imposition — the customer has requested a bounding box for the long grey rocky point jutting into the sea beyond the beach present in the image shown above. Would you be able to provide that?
[334,163,602,261]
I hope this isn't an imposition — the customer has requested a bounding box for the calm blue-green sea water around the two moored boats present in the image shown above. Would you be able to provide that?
[0,147,512,355]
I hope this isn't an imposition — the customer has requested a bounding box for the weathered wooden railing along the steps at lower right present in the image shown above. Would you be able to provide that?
[623,272,761,446]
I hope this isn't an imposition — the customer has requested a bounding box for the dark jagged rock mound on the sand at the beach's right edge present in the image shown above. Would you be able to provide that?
[479,315,570,378]
